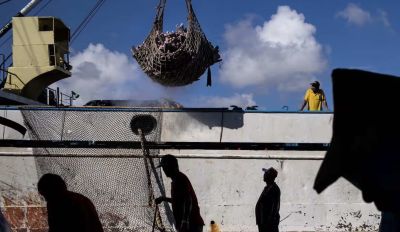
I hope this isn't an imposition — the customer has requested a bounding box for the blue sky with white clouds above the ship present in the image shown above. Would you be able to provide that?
[0,0,400,110]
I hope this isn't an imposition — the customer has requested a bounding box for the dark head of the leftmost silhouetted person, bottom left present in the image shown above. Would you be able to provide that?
[38,173,67,201]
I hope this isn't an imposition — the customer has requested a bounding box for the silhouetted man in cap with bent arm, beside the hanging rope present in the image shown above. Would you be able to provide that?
[156,155,204,232]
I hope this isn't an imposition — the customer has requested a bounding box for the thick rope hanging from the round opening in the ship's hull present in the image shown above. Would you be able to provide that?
[138,128,165,231]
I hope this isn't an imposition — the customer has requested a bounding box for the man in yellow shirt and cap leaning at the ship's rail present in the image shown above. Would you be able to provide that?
[299,81,331,111]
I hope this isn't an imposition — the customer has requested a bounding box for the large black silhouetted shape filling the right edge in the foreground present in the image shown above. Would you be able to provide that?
[314,69,400,212]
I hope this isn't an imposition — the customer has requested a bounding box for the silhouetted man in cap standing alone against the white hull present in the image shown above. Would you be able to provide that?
[256,168,281,232]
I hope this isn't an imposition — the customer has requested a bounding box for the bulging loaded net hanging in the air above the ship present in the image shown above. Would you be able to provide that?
[132,0,221,87]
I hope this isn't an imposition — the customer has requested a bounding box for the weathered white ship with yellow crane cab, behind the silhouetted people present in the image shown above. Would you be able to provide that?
[0,0,380,232]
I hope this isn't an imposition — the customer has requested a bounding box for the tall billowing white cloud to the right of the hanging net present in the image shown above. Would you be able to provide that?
[220,6,327,91]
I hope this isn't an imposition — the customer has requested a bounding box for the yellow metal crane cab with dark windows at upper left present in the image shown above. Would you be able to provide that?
[4,17,71,100]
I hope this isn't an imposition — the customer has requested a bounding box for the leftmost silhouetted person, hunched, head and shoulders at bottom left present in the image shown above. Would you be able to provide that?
[38,174,103,232]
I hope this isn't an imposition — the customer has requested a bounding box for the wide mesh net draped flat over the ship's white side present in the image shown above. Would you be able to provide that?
[21,109,174,232]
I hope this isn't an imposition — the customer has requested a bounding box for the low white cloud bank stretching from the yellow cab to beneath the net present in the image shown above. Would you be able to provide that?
[56,44,256,107]
